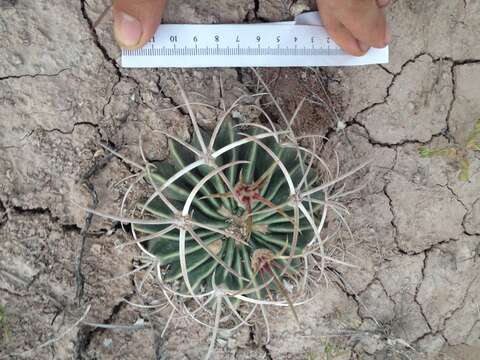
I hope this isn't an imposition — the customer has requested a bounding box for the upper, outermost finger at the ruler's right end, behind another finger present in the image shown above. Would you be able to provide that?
[319,0,390,48]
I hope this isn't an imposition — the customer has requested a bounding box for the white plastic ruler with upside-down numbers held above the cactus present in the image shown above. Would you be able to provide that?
[122,12,388,68]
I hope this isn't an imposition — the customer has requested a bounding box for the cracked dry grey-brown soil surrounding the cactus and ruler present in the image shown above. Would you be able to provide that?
[0,0,480,360]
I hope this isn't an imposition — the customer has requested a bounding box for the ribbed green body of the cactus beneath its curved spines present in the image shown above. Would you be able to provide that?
[133,120,322,299]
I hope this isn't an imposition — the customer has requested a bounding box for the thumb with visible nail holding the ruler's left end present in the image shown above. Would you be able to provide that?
[113,0,166,49]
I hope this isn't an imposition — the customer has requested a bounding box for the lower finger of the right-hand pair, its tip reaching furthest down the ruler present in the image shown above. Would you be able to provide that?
[318,0,369,56]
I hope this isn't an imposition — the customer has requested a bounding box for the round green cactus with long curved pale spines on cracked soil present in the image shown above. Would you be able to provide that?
[85,79,358,357]
